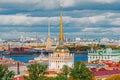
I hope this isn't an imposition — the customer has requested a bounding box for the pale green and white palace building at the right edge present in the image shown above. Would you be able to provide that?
[88,48,120,62]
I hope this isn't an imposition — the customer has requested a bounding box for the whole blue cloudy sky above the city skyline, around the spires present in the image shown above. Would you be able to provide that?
[0,0,120,39]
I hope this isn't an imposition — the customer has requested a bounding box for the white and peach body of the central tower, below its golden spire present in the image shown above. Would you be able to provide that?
[49,47,74,70]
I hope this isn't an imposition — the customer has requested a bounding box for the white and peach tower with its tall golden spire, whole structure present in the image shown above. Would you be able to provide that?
[49,2,74,72]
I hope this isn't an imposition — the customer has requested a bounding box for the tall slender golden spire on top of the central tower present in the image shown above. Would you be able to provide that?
[59,4,64,42]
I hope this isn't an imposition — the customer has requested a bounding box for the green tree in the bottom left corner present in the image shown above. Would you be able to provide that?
[0,64,15,80]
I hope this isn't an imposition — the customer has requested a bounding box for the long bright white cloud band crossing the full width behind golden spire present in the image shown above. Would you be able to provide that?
[0,12,120,27]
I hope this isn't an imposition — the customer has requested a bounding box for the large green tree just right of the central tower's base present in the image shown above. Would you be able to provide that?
[70,62,93,80]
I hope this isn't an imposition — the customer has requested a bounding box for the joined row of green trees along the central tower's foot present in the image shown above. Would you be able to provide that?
[26,62,93,80]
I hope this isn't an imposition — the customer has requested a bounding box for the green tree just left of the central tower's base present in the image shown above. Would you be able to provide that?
[26,64,47,80]
